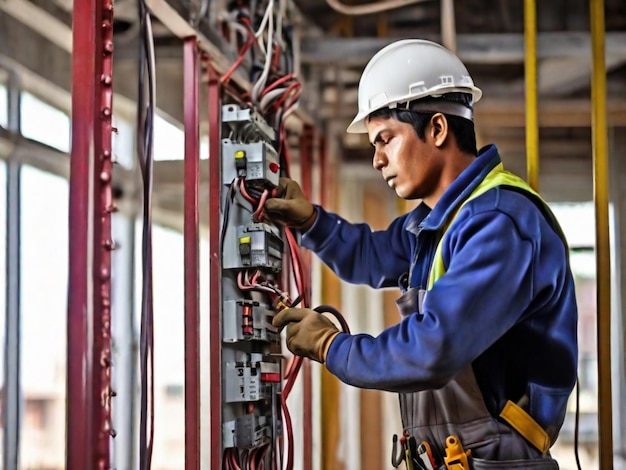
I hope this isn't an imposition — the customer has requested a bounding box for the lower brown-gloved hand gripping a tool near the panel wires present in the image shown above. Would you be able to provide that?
[272,308,340,364]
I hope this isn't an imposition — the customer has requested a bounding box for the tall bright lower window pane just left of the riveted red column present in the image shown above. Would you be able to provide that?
[20,166,69,469]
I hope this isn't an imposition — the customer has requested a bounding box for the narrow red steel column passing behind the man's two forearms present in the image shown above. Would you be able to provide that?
[300,124,315,470]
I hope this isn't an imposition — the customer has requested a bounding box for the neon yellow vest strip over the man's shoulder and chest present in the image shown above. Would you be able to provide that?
[426,163,539,290]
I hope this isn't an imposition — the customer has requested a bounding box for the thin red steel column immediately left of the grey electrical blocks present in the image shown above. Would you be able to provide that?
[207,64,222,468]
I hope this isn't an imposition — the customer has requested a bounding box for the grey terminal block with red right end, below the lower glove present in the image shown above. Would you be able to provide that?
[224,353,280,403]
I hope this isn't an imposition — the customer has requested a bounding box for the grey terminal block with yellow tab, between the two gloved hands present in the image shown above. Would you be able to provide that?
[222,223,283,272]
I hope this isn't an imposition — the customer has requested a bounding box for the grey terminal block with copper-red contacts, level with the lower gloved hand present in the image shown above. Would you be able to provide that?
[222,300,278,343]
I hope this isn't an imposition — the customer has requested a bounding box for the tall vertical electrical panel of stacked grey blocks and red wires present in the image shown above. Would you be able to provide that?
[220,104,285,468]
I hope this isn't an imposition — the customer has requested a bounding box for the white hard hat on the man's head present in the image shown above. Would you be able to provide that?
[347,39,482,133]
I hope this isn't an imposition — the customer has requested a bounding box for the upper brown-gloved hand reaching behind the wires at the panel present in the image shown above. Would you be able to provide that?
[263,178,317,230]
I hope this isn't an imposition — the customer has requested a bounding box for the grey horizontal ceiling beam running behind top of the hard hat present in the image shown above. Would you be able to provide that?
[302,31,626,66]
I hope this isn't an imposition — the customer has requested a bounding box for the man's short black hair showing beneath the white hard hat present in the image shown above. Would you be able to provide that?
[367,93,478,155]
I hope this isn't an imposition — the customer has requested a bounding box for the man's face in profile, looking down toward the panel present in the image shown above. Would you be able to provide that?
[365,117,442,199]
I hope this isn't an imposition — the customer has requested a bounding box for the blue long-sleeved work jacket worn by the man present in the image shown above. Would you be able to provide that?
[302,146,577,435]
